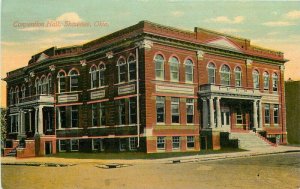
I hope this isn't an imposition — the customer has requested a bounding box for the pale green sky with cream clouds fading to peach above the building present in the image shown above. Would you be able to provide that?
[1,0,300,106]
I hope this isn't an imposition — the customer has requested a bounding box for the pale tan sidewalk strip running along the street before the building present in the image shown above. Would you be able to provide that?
[1,146,300,164]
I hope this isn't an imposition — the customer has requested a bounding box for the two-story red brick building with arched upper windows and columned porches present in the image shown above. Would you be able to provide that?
[5,21,286,156]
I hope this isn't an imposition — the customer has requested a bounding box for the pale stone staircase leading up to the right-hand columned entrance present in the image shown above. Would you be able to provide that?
[229,131,276,150]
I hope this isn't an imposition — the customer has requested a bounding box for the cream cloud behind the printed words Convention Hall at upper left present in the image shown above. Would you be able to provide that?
[18,12,83,32]
